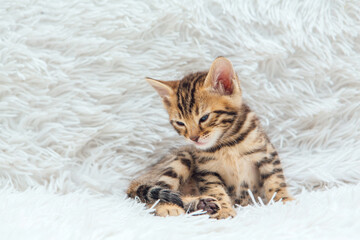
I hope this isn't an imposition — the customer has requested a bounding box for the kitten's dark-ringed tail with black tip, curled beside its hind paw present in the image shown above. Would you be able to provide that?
[127,184,184,208]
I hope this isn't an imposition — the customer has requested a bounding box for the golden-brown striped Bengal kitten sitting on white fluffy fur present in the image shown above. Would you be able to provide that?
[127,57,293,219]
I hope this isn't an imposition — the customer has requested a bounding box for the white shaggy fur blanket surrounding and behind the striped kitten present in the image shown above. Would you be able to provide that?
[0,0,360,240]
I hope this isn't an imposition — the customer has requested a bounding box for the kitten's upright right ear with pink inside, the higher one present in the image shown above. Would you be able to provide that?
[205,57,240,95]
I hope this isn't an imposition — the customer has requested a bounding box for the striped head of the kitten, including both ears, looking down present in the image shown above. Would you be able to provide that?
[147,57,242,149]
